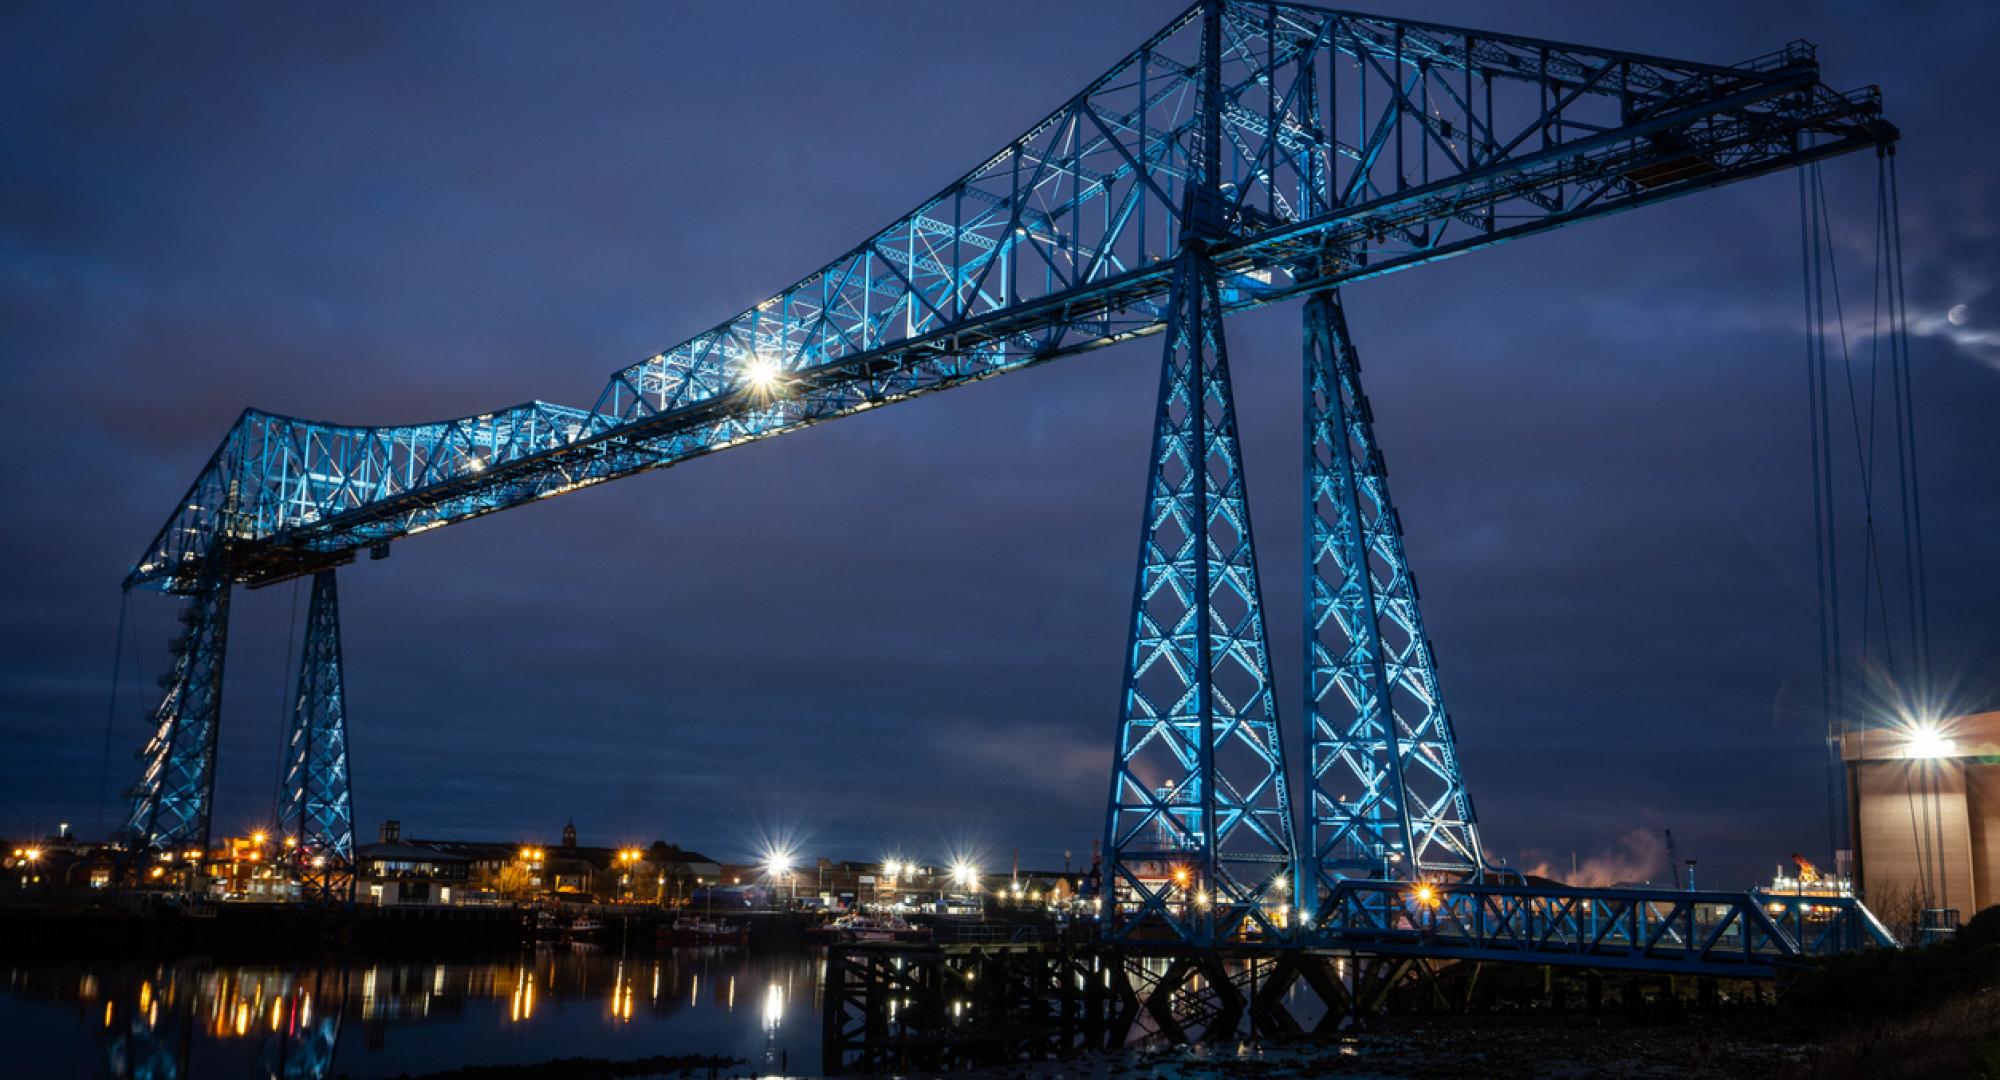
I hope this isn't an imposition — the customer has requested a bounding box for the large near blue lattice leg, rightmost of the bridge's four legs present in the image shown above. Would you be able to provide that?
[1304,292,1482,908]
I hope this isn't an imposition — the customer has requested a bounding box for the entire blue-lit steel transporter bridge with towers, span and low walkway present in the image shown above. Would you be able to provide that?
[126,0,1896,964]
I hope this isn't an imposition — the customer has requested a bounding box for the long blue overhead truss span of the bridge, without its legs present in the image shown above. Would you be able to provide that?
[126,2,1896,592]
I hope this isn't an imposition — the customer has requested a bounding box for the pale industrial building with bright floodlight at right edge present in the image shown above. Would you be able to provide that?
[1840,712,2000,920]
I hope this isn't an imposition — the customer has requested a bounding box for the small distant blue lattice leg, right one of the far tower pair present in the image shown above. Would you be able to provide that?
[278,570,354,900]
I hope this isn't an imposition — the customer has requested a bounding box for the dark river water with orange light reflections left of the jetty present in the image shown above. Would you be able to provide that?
[0,944,824,1078]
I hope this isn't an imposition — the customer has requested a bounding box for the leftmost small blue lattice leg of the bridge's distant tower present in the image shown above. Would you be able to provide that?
[126,552,230,878]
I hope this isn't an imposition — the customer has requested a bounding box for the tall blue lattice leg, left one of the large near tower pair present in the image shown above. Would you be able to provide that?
[1104,248,1294,944]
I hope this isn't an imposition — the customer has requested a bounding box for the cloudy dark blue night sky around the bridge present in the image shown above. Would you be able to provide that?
[0,0,2000,884]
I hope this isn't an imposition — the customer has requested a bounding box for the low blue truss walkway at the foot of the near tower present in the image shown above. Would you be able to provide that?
[1322,880,1896,978]
